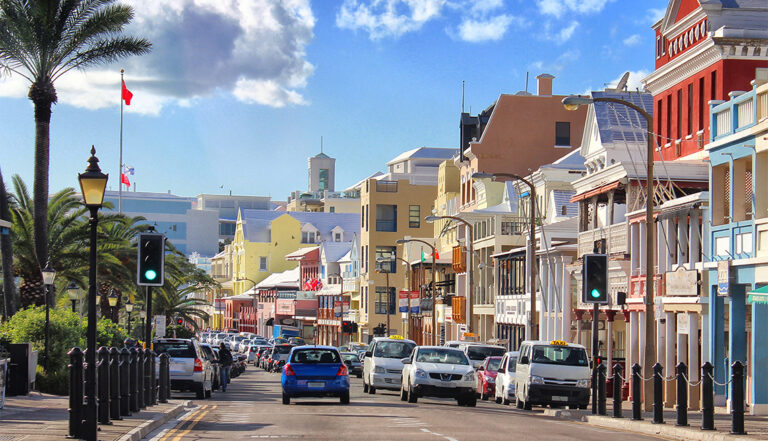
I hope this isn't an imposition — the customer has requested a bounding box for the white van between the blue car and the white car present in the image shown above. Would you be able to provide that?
[363,336,416,394]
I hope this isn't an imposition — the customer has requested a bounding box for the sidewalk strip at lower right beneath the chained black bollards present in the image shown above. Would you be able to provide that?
[544,399,768,441]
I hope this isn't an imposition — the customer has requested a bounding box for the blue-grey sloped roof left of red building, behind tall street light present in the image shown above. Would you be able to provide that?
[582,91,653,145]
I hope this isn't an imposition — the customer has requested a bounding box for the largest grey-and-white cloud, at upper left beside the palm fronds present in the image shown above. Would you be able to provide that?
[0,0,315,114]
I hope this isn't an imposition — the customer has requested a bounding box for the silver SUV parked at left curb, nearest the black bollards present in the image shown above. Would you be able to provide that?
[152,338,213,398]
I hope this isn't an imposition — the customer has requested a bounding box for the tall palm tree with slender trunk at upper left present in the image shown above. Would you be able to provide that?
[0,0,151,278]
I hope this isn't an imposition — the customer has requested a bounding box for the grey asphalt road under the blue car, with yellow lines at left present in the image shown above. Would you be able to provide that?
[146,367,659,441]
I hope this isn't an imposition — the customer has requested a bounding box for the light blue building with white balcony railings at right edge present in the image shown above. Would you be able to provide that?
[703,74,768,415]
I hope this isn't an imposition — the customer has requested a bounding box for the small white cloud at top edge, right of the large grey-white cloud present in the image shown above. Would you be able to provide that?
[336,0,446,40]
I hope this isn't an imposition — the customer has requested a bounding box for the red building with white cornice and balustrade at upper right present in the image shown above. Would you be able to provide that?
[644,0,768,160]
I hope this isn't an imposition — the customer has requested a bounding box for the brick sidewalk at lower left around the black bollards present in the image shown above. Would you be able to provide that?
[0,392,189,441]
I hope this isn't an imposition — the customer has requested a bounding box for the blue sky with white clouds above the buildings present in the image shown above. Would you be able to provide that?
[0,0,667,200]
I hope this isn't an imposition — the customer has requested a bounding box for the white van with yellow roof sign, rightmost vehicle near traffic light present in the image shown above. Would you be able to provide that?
[515,340,591,410]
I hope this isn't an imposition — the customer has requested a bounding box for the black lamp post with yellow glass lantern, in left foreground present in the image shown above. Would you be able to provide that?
[78,146,109,441]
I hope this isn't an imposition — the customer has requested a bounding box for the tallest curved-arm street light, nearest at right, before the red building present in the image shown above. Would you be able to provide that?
[563,95,657,411]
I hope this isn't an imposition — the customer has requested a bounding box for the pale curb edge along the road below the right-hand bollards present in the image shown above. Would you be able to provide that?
[581,415,755,441]
